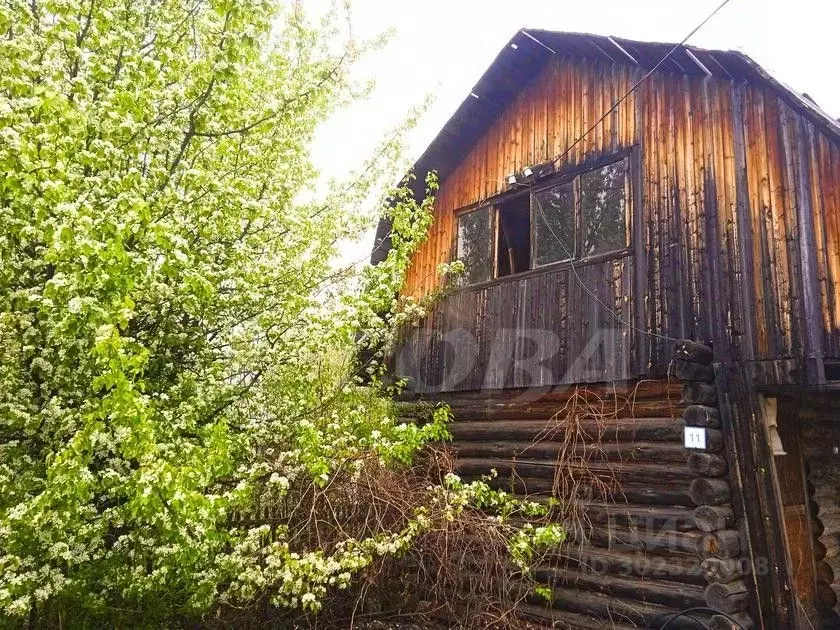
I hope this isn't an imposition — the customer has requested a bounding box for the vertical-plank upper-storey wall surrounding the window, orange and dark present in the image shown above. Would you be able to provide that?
[403,54,840,391]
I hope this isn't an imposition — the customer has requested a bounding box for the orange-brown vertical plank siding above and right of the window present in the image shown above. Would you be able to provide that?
[403,58,840,390]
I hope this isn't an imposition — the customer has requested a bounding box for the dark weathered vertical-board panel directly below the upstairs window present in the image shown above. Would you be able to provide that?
[396,256,637,392]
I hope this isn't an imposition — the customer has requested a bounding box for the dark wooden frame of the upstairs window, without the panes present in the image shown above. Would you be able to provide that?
[449,145,639,291]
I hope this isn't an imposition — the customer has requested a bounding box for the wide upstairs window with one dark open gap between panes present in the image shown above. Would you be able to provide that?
[456,158,630,286]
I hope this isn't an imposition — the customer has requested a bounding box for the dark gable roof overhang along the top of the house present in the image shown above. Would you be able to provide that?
[371,28,840,264]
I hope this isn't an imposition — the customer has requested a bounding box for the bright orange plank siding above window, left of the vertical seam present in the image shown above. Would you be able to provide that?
[404,60,636,296]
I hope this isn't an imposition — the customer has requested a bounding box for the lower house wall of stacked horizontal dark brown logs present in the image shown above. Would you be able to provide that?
[404,378,757,629]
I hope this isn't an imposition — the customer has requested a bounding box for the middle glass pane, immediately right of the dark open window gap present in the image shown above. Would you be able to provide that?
[533,184,575,267]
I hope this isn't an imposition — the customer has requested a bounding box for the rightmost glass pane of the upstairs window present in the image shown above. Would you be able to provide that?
[579,160,627,258]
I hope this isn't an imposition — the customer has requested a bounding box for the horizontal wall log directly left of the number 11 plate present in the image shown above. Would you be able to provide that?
[449,417,685,443]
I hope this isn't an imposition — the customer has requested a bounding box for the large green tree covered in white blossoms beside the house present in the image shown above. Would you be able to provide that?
[0,0,564,623]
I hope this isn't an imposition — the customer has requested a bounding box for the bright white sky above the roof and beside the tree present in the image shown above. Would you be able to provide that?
[305,0,840,260]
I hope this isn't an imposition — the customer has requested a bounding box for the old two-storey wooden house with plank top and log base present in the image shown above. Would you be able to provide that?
[372,30,840,628]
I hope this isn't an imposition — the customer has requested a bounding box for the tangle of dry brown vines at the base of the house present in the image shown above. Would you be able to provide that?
[217,446,556,628]
